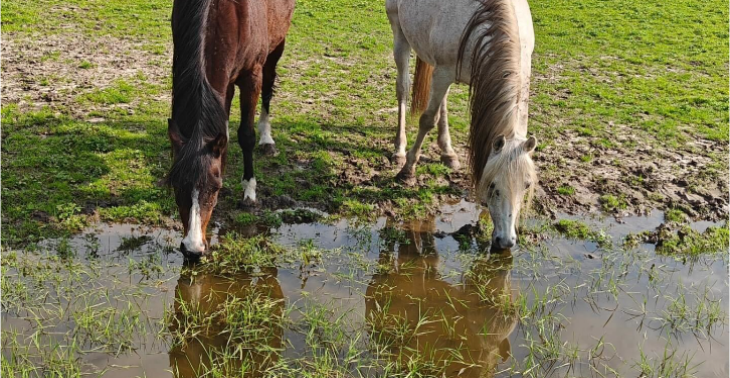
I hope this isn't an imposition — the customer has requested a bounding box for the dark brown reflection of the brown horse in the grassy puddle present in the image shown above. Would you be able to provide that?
[170,268,284,378]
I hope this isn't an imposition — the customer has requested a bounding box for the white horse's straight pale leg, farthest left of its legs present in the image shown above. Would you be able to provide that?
[388,9,411,167]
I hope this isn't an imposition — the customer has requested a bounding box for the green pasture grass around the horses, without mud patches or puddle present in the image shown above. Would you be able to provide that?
[2,0,728,244]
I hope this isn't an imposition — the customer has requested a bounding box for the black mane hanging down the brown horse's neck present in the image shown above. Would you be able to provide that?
[167,0,228,187]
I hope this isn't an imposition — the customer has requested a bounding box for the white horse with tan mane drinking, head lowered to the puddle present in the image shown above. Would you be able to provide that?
[386,0,537,249]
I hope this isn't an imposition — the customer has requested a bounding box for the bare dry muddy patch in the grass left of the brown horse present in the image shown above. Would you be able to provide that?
[2,33,172,117]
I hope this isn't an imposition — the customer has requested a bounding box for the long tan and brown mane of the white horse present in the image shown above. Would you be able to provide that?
[457,0,521,186]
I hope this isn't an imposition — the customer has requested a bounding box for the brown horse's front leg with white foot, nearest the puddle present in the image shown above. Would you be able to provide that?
[236,71,261,204]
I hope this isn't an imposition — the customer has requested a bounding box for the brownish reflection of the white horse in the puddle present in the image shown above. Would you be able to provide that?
[365,220,518,377]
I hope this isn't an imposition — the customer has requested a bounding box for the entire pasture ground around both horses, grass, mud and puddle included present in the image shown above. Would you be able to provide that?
[1,0,730,378]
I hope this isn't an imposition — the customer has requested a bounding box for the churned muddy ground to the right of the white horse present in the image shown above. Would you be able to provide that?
[530,58,730,221]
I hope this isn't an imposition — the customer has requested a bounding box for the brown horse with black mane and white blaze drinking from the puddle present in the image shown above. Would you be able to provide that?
[167,0,294,257]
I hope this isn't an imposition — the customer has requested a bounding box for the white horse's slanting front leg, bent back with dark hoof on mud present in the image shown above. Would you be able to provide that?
[396,67,454,184]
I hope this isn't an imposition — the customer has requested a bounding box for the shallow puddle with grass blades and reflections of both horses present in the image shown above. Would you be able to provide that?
[1,214,727,377]
